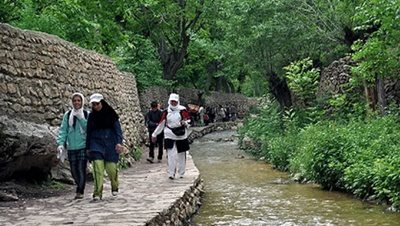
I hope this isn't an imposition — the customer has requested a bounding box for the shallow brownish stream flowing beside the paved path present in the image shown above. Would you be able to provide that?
[190,131,400,226]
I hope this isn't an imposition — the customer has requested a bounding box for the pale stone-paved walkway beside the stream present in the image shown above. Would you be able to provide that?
[0,155,199,226]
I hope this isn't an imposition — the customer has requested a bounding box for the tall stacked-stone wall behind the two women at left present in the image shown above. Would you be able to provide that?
[0,23,145,149]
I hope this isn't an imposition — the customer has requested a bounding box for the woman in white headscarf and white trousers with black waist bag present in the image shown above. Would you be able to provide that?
[152,93,190,180]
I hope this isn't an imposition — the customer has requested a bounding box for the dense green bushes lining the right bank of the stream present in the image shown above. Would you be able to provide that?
[240,102,400,209]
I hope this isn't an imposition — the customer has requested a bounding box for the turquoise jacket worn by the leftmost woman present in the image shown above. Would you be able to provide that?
[57,111,87,150]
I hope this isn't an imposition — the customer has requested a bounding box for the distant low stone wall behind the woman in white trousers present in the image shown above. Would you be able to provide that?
[140,87,258,117]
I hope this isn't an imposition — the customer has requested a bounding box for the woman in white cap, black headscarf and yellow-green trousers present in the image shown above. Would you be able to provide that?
[86,93,123,201]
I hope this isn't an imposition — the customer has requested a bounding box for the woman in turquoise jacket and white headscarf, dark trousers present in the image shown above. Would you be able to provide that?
[57,93,88,199]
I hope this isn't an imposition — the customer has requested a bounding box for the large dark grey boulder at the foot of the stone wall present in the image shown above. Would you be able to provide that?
[0,115,71,181]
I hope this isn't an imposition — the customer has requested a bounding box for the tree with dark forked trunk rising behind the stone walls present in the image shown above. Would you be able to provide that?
[134,0,204,80]
